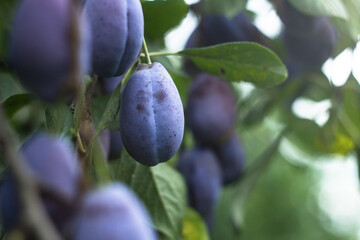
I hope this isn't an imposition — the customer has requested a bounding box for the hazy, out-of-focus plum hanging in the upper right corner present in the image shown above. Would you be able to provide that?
[276,0,337,72]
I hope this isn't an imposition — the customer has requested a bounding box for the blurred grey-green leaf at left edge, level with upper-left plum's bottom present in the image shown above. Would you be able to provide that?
[0,72,26,102]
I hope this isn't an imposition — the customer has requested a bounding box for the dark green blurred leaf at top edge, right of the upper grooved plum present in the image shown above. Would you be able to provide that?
[142,0,188,39]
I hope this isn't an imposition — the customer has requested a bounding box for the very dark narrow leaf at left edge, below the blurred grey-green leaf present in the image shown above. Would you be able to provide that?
[2,93,35,118]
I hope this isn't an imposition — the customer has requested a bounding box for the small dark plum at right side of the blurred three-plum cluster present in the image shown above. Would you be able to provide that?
[216,133,245,184]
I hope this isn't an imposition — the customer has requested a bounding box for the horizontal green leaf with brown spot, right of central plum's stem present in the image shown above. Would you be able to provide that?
[177,42,287,87]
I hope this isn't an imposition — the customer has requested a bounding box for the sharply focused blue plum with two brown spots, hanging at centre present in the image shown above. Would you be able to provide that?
[120,63,184,166]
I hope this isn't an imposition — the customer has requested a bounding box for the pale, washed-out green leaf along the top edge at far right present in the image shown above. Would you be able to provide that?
[289,0,348,19]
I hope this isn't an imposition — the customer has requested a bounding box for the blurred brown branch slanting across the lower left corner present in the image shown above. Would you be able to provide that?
[0,106,62,240]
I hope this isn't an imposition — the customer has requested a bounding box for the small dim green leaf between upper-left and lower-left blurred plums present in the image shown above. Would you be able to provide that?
[45,104,74,138]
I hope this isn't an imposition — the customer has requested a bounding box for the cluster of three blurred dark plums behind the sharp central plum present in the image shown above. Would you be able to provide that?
[178,74,244,230]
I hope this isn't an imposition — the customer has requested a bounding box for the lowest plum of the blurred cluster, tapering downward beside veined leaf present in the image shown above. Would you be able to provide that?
[177,148,222,229]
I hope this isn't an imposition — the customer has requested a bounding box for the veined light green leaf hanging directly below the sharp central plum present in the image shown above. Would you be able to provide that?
[115,149,187,239]
